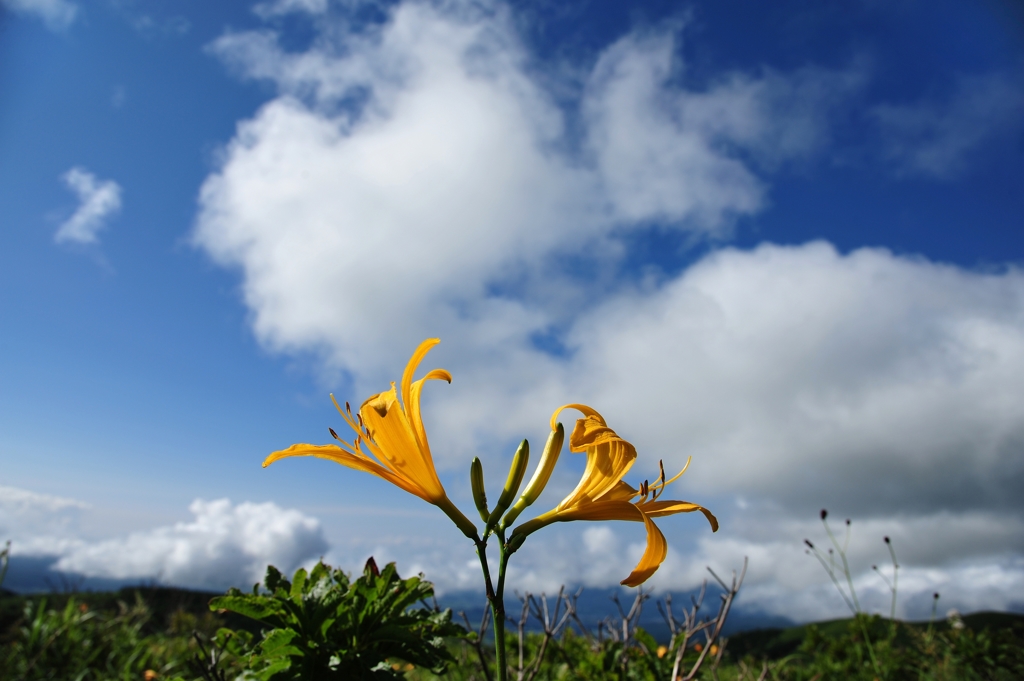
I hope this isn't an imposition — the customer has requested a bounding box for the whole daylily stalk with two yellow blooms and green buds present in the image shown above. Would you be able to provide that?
[263,338,718,681]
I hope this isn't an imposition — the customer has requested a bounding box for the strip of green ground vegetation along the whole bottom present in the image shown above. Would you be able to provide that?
[0,555,1024,681]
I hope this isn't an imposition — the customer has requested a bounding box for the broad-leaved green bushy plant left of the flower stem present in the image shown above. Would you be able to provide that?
[210,558,466,681]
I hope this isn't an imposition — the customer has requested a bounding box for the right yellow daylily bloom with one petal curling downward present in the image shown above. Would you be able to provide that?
[510,405,718,587]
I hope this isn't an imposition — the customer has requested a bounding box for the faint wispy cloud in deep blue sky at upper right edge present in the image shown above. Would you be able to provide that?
[871,74,1024,179]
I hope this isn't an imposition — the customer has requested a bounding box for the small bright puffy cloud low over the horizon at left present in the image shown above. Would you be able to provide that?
[53,499,327,589]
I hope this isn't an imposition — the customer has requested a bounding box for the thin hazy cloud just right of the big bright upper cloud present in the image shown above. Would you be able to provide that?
[583,32,862,225]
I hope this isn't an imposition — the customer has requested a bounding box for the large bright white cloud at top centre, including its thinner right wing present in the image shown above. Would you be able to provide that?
[195,3,851,373]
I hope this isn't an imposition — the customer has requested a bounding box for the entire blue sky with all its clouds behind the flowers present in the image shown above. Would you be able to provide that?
[0,0,1024,619]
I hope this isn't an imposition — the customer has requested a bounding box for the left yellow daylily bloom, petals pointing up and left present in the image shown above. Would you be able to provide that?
[263,338,476,539]
